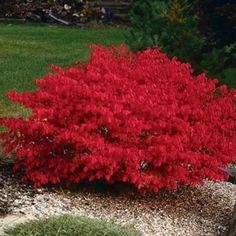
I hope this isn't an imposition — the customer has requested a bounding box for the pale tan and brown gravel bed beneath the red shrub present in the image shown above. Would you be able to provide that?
[0,164,236,236]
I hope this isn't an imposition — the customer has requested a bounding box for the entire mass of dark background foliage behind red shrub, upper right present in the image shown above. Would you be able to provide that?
[125,0,236,87]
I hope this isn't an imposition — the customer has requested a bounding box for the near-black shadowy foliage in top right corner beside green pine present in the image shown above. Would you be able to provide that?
[194,0,236,50]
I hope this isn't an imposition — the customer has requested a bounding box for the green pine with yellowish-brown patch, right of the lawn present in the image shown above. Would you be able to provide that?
[126,0,205,68]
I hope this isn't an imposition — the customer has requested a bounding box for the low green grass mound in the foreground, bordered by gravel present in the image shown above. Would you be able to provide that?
[5,215,140,236]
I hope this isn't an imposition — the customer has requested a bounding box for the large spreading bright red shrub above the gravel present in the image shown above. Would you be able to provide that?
[2,46,236,191]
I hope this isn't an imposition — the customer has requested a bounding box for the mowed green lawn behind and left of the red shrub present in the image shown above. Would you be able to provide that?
[0,22,124,116]
